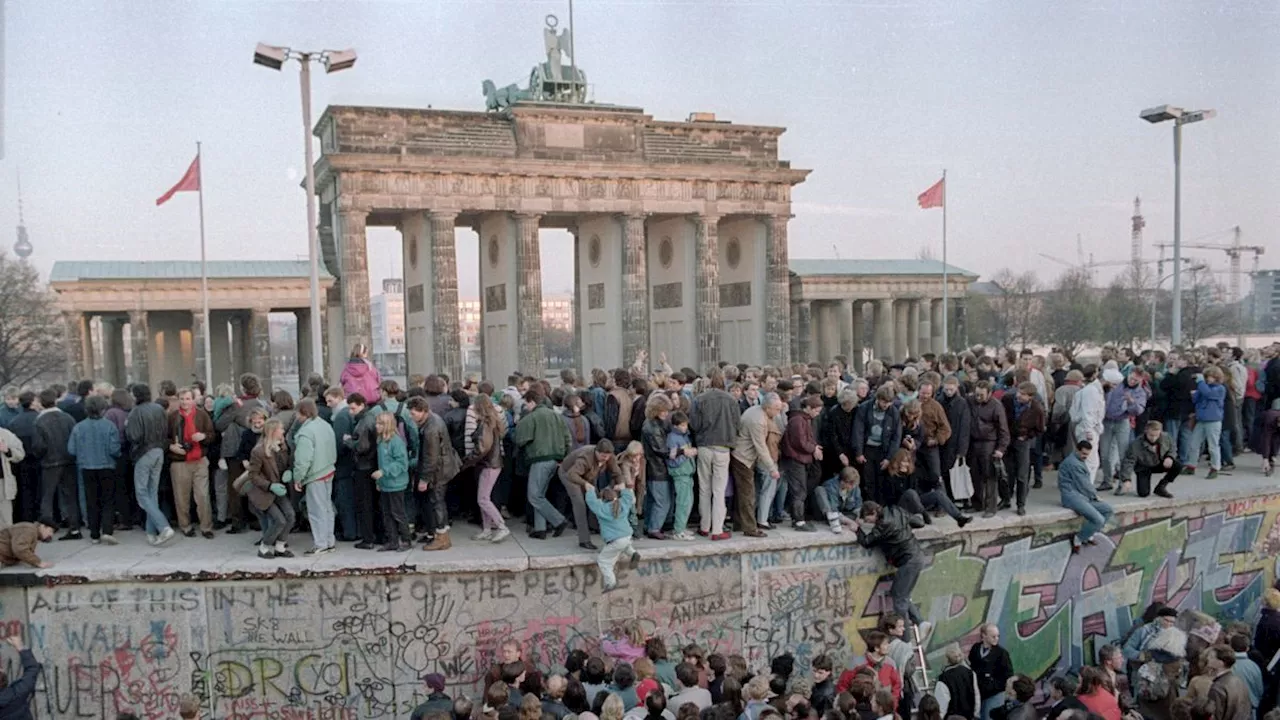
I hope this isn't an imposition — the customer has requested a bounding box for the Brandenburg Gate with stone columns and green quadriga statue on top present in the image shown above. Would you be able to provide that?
[315,20,808,378]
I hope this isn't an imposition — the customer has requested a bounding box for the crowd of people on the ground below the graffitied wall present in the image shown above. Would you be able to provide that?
[389,589,1280,720]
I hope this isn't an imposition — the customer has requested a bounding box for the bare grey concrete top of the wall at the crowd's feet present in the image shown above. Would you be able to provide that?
[0,455,1280,584]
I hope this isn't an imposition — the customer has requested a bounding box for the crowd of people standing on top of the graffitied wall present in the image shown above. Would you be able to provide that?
[0,345,1280,568]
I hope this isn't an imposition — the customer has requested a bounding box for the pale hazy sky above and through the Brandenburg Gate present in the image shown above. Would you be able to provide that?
[0,0,1280,296]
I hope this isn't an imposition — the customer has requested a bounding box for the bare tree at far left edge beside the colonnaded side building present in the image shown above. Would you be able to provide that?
[0,251,67,386]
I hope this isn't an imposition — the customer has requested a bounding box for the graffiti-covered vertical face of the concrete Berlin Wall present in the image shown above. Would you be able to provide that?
[0,495,1280,720]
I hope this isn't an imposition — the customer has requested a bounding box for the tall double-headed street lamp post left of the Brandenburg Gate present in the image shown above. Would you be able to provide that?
[253,42,356,374]
